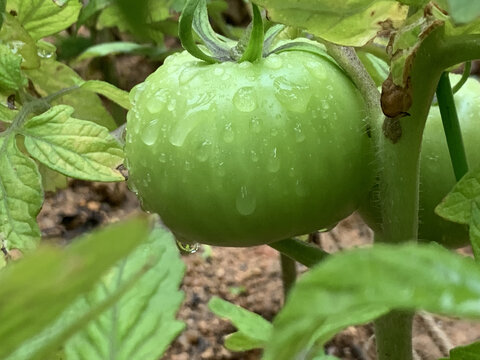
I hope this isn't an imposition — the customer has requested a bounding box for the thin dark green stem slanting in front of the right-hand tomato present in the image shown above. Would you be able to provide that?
[437,72,468,181]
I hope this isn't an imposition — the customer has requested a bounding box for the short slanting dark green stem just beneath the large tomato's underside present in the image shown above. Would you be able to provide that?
[269,239,328,267]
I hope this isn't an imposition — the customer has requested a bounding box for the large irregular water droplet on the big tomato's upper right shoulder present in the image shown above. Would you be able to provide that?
[273,76,312,113]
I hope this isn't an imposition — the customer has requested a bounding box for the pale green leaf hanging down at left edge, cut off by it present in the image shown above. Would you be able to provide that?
[0,135,43,250]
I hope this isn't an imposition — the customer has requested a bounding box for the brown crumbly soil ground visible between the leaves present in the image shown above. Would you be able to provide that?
[38,181,480,360]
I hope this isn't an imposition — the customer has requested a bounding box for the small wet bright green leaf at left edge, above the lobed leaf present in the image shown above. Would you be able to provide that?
[0,43,27,90]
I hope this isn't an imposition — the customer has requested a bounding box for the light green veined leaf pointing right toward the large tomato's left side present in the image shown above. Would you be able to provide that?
[21,105,125,181]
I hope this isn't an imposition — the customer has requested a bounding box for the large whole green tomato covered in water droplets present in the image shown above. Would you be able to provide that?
[125,45,372,246]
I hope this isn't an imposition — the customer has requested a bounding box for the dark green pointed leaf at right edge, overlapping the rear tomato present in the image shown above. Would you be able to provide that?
[435,168,480,255]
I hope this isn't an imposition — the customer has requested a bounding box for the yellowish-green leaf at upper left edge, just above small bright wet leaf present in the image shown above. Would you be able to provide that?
[0,14,40,69]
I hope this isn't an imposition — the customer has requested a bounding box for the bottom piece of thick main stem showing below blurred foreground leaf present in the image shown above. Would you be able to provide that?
[375,311,413,360]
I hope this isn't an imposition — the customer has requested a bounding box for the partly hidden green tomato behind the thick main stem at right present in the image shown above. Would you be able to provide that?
[359,74,480,248]
